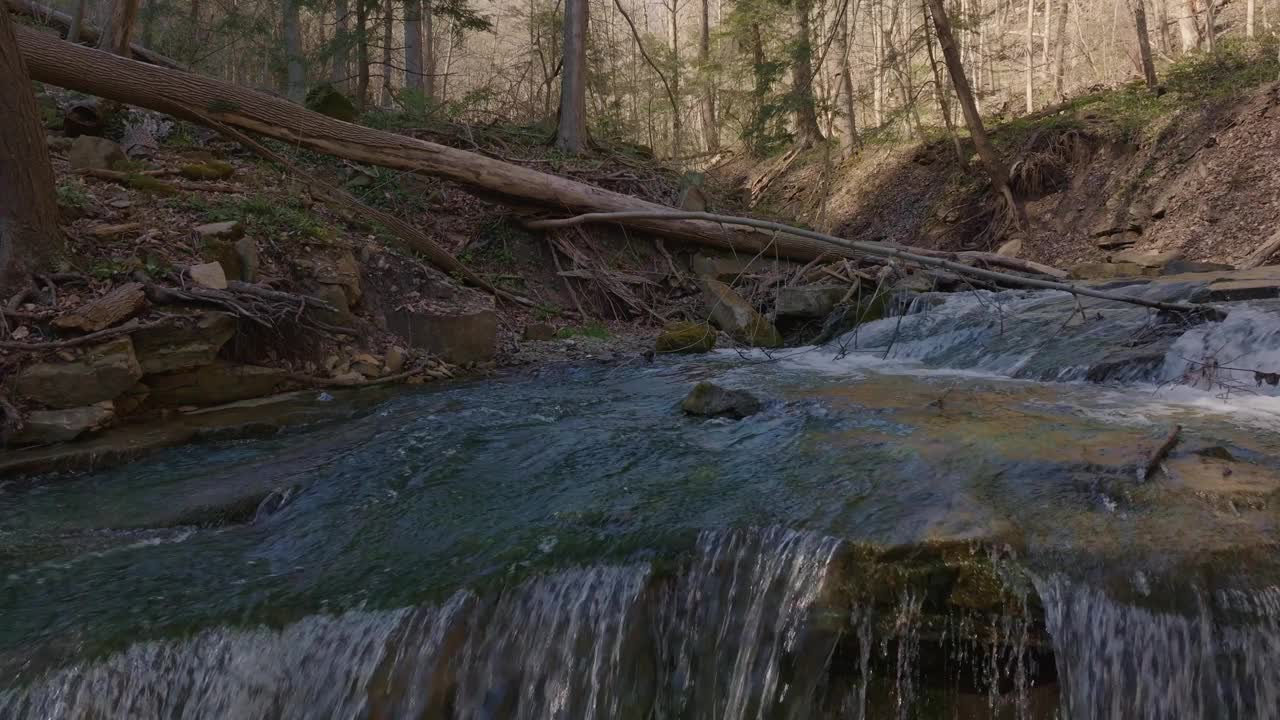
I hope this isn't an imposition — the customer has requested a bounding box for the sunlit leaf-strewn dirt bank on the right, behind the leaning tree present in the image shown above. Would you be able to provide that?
[717,49,1280,268]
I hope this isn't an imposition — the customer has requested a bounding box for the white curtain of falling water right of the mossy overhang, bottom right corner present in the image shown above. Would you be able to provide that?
[1037,575,1280,720]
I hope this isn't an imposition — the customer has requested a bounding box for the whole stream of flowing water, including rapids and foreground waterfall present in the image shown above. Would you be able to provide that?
[0,287,1280,719]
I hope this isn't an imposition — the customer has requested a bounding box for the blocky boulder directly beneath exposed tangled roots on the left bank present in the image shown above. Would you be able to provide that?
[133,311,237,375]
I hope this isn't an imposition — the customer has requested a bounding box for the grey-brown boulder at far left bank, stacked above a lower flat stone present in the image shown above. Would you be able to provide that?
[17,337,142,407]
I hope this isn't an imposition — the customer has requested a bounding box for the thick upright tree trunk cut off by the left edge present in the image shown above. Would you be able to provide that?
[0,12,67,292]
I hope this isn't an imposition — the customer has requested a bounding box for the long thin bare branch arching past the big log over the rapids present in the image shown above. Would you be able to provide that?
[529,210,1222,319]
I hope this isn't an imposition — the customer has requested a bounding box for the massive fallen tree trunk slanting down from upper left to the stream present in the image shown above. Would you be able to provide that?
[18,28,1059,278]
